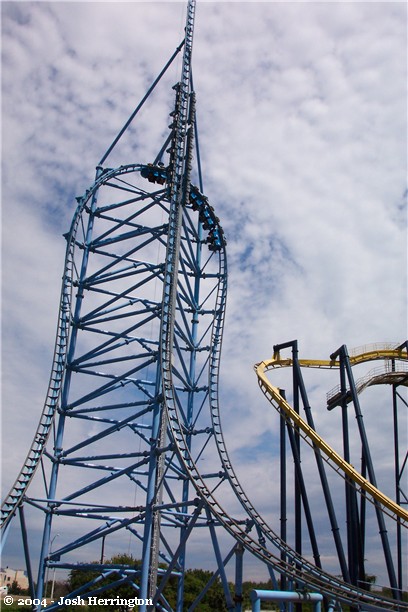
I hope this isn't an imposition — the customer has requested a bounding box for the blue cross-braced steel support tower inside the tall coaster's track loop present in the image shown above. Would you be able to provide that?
[2,2,233,596]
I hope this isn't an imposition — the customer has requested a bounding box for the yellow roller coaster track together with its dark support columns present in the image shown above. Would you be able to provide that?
[255,341,408,599]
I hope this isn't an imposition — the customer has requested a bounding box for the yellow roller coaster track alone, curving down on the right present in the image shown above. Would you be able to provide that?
[255,345,408,527]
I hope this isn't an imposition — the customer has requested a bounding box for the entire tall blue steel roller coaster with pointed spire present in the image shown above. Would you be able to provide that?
[3,0,406,612]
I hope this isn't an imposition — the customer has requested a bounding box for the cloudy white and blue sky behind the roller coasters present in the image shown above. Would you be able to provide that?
[1,1,407,592]
